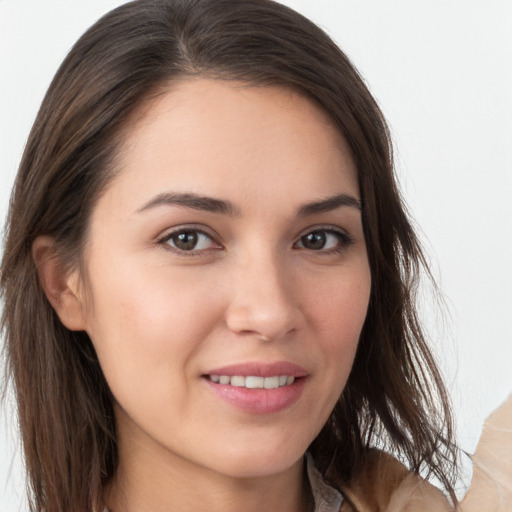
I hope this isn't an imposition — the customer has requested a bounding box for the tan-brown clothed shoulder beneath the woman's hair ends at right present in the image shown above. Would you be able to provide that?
[341,450,452,512]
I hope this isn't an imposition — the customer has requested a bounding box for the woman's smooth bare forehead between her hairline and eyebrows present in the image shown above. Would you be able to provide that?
[105,79,358,212]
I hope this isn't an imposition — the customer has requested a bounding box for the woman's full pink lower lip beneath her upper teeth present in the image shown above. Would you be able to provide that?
[205,377,306,414]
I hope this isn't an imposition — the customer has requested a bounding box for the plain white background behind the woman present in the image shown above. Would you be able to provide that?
[0,0,512,512]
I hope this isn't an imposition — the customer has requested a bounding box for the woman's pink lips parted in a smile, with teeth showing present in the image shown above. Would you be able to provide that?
[203,361,308,415]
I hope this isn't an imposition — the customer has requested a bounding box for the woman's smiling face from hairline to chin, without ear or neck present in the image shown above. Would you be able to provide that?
[77,79,370,477]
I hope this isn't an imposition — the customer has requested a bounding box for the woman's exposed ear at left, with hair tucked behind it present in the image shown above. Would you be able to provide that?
[32,236,85,331]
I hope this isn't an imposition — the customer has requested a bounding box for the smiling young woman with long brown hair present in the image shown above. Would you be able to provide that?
[1,0,456,512]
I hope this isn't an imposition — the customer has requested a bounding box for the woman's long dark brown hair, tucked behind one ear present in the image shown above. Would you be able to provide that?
[0,0,456,512]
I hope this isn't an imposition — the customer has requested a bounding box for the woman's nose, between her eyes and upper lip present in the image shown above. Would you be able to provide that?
[226,251,301,341]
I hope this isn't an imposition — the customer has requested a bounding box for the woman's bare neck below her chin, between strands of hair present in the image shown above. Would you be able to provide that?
[104,422,314,512]
